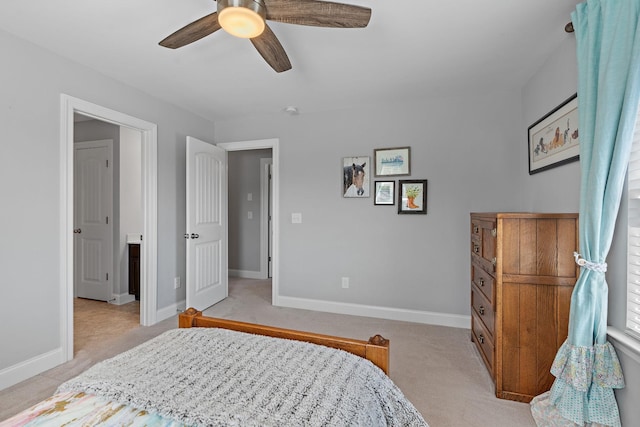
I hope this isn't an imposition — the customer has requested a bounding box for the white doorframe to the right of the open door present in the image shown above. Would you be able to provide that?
[216,138,280,305]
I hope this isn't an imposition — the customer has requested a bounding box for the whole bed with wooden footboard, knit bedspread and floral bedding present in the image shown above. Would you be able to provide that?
[0,308,427,427]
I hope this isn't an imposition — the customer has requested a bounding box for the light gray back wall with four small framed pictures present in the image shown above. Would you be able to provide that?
[216,91,526,318]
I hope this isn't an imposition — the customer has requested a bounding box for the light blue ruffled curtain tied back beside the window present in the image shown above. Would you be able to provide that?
[531,0,640,427]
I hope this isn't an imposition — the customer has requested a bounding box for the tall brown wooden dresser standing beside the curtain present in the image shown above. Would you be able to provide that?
[471,213,579,402]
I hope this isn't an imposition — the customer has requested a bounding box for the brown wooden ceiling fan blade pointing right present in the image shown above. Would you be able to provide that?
[265,0,371,28]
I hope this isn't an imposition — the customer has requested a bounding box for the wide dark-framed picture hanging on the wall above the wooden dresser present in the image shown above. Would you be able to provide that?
[529,94,580,175]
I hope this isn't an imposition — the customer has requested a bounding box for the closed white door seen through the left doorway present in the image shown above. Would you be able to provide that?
[73,140,113,301]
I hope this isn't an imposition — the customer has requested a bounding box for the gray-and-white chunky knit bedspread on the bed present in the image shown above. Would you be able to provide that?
[58,328,427,426]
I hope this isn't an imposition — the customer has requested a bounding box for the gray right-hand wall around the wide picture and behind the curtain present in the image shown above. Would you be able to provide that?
[521,35,640,426]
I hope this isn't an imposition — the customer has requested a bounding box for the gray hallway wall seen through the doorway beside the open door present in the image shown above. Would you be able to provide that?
[228,149,271,273]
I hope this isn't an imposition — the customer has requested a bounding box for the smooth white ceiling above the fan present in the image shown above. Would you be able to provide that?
[0,0,578,120]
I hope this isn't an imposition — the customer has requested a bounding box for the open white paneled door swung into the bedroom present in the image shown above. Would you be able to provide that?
[185,137,229,310]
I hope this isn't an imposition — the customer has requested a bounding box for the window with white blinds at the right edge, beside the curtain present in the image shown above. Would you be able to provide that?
[627,116,640,339]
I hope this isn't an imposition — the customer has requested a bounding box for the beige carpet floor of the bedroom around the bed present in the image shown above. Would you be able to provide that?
[0,279,535,427]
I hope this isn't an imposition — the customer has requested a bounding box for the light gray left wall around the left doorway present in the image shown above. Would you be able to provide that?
[0,27,213,387]
